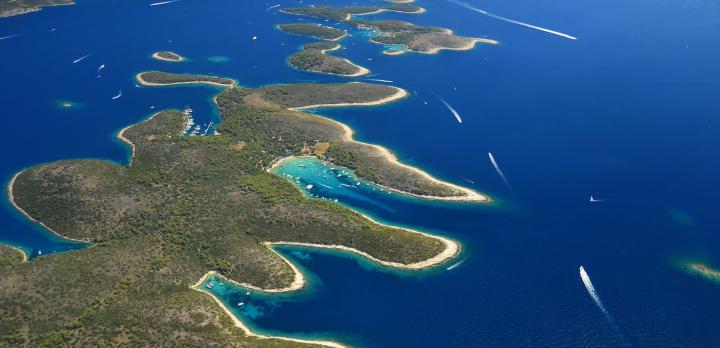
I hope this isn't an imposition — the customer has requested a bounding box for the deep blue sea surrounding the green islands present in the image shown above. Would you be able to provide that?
[0,0,720,347]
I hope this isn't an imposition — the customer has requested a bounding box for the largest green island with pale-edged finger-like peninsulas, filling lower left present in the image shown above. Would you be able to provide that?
[0,72,486,347]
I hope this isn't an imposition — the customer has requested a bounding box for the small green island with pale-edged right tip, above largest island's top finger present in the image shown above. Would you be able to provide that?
[288,42,370,77]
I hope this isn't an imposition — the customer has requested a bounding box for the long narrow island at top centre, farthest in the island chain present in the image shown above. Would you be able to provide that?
[280,3,425,21]
